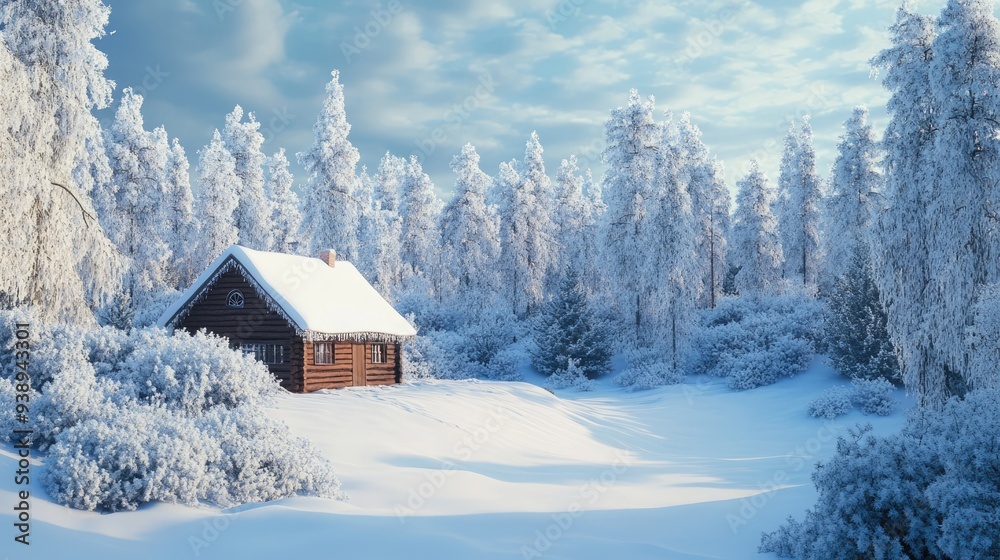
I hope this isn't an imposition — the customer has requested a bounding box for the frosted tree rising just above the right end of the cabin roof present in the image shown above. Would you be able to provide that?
[399,156,442,291]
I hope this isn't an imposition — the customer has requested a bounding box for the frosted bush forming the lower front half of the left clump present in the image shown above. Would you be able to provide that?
[43,405,341,511]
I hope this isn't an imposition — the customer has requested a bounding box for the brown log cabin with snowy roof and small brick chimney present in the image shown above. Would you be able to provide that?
[158,245,416,393]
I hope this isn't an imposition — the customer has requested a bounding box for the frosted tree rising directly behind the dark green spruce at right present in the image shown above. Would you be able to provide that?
[824,107,883,281]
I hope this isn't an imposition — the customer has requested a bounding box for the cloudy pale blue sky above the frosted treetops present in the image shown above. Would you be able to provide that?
[98,0,944,194]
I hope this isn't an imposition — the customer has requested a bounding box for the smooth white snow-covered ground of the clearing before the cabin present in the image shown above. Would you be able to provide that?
[0,363,910,559]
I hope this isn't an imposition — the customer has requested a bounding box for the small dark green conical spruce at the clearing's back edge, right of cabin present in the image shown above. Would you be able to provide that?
[531,271,613,379]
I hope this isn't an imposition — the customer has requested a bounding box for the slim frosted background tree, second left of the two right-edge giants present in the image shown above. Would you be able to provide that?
[778,117,823,287]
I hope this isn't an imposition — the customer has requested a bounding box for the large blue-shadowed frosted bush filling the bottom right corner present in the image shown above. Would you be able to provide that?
[760,390,1000,560]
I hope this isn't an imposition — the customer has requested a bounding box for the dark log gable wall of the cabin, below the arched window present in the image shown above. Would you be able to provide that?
[177,269,304,391]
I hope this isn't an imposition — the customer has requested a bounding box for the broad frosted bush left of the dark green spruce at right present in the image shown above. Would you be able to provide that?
[691,295,825,390]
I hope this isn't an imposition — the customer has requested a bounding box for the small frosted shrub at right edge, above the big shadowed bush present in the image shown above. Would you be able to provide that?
[965,284,1000,389]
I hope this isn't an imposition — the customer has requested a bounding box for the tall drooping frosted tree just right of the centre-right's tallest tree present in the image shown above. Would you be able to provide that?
[642,115,704,371]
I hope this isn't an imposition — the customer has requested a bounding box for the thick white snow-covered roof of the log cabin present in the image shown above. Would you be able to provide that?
[158,245,417,341]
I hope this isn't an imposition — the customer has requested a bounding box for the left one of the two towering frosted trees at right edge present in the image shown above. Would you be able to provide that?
[871,4,947,402]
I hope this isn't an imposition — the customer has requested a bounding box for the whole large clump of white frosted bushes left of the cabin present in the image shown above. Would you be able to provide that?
[0,312,340,510]
